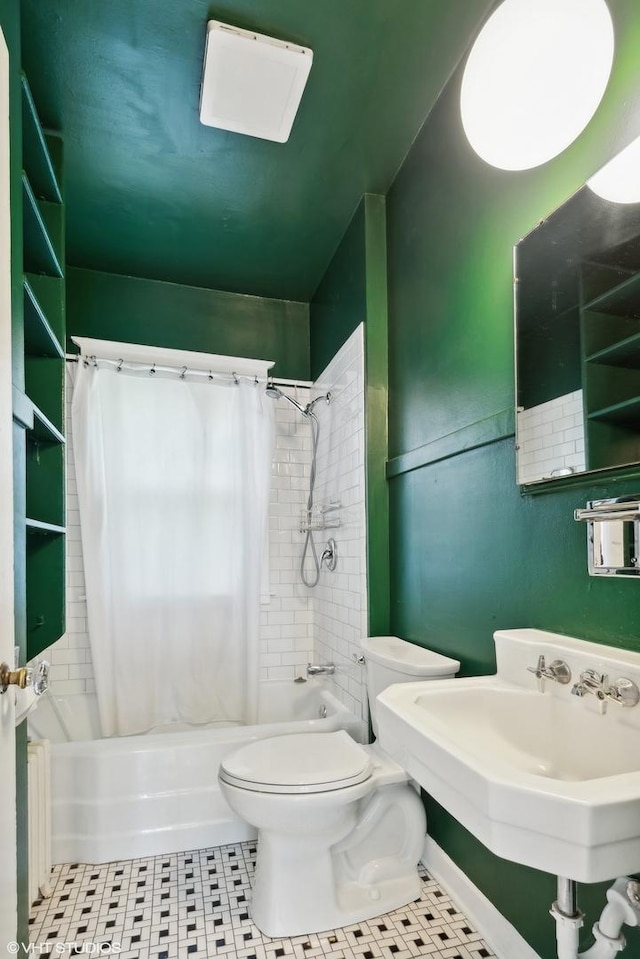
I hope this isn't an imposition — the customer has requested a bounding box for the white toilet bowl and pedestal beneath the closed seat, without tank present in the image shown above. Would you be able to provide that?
[220,733,427,939]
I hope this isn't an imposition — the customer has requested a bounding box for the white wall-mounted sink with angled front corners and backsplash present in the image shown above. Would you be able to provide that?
[378,630,640,882]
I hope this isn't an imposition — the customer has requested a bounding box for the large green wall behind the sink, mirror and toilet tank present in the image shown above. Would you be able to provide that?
[387,0,640,959]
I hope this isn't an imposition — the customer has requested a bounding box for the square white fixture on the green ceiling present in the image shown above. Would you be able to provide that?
[200,20,313,143]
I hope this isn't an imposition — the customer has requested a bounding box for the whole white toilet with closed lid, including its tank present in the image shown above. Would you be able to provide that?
[219,636,460,938]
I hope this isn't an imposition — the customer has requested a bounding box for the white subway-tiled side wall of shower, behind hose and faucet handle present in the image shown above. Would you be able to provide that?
[313,325,368,742]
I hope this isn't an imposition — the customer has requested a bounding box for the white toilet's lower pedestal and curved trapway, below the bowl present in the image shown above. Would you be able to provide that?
[250,783,426,939]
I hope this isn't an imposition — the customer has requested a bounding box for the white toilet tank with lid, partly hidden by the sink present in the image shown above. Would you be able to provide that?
[362,636,460,735]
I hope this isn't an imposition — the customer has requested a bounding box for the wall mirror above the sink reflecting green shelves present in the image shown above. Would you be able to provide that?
[514,142,640,485]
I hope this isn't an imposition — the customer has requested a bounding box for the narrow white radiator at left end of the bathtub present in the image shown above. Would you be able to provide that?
[27,739,52,903]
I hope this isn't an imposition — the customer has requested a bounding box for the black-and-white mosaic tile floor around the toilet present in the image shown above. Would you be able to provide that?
[29,843,493,959]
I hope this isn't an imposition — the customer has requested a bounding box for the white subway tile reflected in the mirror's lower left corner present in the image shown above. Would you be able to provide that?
[518,390,586,483]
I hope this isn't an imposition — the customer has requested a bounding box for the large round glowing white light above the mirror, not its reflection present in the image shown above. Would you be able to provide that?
[460,0,614,170]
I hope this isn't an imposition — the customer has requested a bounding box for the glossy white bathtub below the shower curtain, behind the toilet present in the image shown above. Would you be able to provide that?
[30,680,362,864]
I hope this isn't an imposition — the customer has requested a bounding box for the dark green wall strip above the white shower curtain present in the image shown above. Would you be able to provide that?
[67,269,309,380]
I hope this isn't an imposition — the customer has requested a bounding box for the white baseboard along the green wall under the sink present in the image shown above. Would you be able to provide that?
[422,836,540,959]
